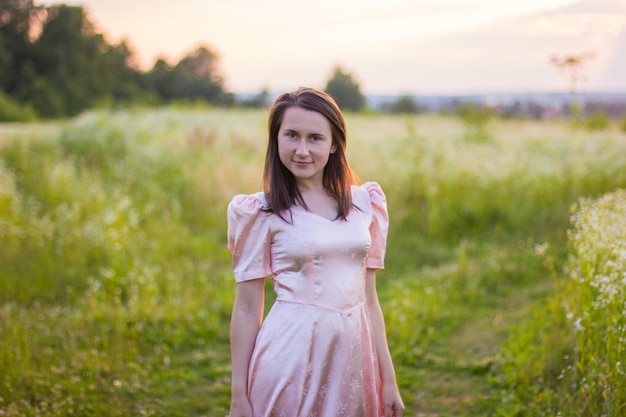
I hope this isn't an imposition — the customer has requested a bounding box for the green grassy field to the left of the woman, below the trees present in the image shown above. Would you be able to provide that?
[0,111,262,415]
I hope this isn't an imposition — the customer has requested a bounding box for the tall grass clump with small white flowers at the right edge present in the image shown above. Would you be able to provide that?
[492,190,626,417]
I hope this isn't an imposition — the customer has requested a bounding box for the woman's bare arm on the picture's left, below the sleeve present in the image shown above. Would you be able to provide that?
[229,279,265,417]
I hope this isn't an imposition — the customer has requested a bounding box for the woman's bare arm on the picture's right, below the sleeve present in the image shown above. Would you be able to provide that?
[365,269,404,417]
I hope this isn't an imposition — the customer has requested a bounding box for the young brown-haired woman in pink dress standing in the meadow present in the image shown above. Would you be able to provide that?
[228,88,404,417]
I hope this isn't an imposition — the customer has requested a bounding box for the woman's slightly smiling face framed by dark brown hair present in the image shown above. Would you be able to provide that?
[278,107,335,186]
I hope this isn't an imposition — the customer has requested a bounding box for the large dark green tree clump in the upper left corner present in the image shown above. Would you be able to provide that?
[0,0,149,117]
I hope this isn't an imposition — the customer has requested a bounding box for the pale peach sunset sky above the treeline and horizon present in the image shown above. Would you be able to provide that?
[36,0,626,95]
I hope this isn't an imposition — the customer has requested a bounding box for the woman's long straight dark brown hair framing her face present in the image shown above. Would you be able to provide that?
[263,87,358,220]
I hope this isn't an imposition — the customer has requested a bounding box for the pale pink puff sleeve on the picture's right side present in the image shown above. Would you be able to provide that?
[361,182,389,269]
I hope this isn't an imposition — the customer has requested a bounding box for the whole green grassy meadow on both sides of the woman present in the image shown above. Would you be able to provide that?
[0,106,626,417]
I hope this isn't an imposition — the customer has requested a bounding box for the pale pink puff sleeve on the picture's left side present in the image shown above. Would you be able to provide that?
[227,193,272,283]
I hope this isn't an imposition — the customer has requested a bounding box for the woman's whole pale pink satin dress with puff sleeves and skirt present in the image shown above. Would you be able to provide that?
[228,182,388,417]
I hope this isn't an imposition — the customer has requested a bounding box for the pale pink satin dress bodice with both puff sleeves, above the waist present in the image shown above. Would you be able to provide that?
[228,183,388,311]
